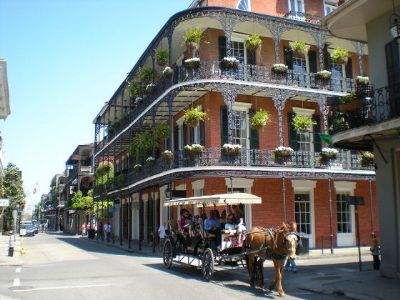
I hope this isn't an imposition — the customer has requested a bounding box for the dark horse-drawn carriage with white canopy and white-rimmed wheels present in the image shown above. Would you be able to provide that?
[163,193,261,280]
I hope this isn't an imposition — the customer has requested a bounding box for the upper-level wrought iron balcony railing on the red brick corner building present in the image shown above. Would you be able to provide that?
[96,61,355,148]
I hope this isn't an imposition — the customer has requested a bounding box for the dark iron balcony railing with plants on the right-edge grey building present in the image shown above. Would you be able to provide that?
[329,85,400,134]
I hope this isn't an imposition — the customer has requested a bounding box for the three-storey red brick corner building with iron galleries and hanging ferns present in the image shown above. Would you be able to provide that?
[94,0,378,248]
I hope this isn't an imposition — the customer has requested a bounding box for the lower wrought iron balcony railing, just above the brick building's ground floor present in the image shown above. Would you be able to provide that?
[95,148,374,193]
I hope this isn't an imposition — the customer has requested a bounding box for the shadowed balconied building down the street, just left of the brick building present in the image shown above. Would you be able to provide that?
[60,144,93,234]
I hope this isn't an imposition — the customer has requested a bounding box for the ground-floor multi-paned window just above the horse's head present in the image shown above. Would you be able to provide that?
[294,194,311,234]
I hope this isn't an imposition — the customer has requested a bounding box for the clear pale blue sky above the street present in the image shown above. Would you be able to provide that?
[0,0,191,212]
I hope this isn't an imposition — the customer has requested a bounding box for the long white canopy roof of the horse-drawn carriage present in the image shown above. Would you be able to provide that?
[164,193,261,207]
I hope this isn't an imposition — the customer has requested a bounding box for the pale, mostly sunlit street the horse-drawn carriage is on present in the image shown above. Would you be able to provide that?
[0,234,362,300]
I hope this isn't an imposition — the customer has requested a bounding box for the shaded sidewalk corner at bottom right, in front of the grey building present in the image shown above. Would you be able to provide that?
[300,271,400,300]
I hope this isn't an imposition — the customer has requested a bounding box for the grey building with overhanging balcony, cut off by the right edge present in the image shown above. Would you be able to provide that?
[324,0,400,278]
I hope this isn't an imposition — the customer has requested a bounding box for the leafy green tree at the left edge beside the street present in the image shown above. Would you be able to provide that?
[2,163,25,230]
